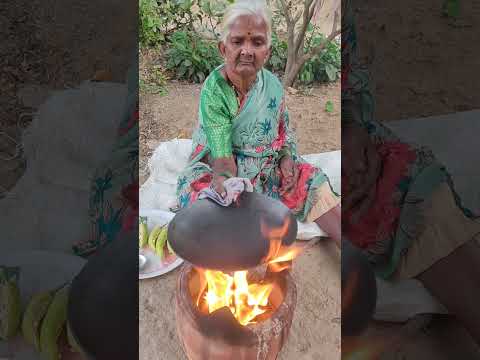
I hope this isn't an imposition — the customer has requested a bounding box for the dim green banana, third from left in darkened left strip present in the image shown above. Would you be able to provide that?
[40,286,69,360]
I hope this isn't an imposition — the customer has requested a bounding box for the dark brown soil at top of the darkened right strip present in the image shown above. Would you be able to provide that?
[354,0,480,120]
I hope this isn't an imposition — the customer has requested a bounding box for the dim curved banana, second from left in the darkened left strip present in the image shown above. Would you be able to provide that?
[22,291,53,351]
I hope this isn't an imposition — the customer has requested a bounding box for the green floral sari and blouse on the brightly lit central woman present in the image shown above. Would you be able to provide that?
[177,65,338,221]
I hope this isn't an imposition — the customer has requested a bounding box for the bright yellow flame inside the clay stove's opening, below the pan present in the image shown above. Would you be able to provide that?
[197,270,273,325]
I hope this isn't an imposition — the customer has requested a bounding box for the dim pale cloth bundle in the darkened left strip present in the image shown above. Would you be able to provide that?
[0,81,127,252]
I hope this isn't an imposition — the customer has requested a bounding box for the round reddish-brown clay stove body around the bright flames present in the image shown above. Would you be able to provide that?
[175,265,297,360]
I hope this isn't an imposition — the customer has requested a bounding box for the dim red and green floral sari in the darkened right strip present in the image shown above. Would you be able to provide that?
[342,1,476,279]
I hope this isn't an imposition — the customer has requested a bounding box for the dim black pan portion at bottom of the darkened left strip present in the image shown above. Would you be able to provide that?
[67,228,138,360]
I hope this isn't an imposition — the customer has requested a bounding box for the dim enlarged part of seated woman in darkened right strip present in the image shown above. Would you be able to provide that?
[342,1,480,344]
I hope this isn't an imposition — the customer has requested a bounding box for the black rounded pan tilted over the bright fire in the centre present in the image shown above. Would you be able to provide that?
[168,192,297,271]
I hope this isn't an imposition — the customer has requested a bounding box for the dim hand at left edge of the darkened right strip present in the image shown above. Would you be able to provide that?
[342,125,381,213]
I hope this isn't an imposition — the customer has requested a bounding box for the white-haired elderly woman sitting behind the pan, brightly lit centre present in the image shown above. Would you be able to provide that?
[177,1,340,244]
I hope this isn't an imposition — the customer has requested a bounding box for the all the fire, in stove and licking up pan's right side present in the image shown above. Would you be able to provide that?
[197,218,305,326]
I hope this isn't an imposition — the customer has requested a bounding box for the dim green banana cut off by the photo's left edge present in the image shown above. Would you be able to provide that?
[0,267,22,340]
